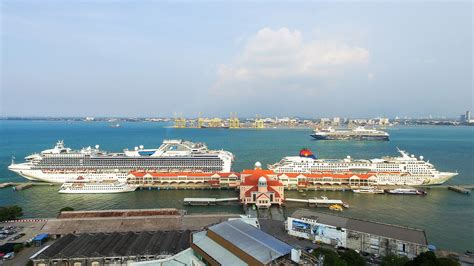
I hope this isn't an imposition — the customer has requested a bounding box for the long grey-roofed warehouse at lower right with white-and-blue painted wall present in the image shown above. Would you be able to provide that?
[287,210,428,258]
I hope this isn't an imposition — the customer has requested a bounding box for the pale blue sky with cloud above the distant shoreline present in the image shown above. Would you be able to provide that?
[0,0,474,118]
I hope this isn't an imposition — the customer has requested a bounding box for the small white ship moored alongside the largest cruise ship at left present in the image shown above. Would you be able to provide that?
[59,177,137,194]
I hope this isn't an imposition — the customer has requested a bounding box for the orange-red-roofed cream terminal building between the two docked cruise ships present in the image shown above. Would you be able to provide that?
[240,162,285,208]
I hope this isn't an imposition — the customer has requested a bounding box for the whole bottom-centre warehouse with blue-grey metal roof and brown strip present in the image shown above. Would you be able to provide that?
[191,219,292,265]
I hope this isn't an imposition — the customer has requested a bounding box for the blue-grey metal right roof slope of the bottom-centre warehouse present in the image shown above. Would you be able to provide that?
[209,220,292,264]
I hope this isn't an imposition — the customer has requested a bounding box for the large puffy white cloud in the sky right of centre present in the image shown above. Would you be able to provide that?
[213,28,370,94]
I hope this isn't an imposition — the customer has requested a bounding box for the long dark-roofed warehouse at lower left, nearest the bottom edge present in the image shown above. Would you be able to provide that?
[32,230,191,266]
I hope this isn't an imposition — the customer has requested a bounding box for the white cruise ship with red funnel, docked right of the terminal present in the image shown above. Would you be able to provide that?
[268,148,457,186]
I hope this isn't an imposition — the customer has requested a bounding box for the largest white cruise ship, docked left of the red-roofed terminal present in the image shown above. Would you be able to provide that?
[8,140,234,183]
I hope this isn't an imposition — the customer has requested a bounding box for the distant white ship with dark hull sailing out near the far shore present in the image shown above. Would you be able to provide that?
[311,127,390,140]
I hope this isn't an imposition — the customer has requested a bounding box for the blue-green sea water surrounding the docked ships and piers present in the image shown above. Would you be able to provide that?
[0,121,474,252]
